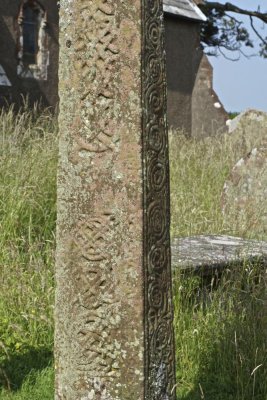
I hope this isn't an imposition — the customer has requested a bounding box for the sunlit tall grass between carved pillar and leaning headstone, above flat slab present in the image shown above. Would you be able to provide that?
[170,131,266,239]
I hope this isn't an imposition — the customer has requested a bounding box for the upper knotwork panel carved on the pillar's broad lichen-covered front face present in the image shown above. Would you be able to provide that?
[72,0,118,158]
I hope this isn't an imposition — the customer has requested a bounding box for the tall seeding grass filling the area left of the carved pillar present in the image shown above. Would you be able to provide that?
[0,104,57,399]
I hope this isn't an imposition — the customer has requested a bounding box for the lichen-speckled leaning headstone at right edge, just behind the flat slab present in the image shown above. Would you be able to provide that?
[222,144,267,234]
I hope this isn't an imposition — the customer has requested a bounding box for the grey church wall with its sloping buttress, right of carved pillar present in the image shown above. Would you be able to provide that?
[165,14,228,137]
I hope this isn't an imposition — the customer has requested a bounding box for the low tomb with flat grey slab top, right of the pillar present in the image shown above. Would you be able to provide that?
[171,235,267,308]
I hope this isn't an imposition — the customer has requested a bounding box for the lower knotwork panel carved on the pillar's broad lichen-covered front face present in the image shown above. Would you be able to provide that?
[70,211,119,379]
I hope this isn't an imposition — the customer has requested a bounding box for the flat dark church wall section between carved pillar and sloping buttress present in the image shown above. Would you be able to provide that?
[165,14,200,134]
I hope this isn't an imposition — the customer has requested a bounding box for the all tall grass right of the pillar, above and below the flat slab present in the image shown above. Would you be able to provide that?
[170,132,267,400]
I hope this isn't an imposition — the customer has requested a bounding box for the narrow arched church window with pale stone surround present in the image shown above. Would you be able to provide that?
[18,0,49,80]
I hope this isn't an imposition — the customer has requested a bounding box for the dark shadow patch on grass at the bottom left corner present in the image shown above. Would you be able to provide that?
[0,348,53,391]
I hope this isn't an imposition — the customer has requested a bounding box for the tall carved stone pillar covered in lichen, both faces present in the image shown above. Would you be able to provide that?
[55,0,175,400]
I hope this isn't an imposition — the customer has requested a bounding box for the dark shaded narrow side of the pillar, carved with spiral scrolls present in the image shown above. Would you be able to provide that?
[142,0,175,400]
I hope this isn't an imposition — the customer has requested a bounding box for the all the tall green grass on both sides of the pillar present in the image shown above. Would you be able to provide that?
[0,110,267,400]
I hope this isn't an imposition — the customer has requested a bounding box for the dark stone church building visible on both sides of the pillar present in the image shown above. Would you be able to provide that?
[0,0,228,137]
